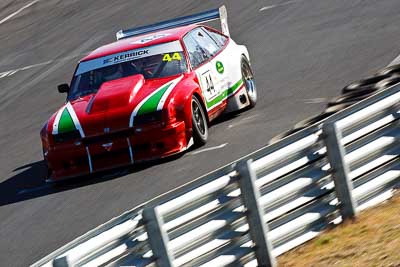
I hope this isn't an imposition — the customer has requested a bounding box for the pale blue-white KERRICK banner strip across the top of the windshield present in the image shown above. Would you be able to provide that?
[75,41,183,76]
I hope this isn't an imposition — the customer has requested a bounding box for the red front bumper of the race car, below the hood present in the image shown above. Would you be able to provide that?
[45,121,188,181]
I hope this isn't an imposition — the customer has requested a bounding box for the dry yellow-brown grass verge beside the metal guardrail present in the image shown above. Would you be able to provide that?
[278,194,400,267]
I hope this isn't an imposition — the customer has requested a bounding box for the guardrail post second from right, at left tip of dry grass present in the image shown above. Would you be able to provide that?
[237,159,276,267]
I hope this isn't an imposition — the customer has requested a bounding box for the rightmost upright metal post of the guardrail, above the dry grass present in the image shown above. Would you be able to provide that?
[322,122,357,220]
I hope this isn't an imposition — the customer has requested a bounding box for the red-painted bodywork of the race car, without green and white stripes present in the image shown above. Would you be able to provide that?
[40,25,238,180]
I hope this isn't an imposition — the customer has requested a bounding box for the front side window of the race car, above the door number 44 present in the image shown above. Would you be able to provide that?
[183,28,219,68]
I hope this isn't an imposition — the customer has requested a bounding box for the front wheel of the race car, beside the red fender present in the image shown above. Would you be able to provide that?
[191,96,208,146]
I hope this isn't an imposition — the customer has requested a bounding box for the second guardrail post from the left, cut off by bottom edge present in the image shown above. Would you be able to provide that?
[143,207,174,267]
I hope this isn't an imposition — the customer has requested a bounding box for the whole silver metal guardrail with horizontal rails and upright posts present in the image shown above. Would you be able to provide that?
[33,85,400,266]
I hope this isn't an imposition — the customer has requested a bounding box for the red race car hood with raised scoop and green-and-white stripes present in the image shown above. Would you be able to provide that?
[49,74,183,137]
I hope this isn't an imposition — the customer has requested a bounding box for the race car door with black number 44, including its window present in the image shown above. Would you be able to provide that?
[183,27,226,111]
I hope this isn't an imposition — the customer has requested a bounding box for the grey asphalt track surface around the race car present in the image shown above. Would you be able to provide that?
[0,0,400,266]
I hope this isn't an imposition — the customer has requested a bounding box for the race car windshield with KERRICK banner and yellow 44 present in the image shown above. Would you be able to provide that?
[68,41,187,100]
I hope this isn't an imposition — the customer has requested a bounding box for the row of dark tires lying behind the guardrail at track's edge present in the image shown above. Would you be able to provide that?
[269,64,400,144]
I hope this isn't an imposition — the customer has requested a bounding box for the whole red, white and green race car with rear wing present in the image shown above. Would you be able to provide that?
[41,6,257,181]
